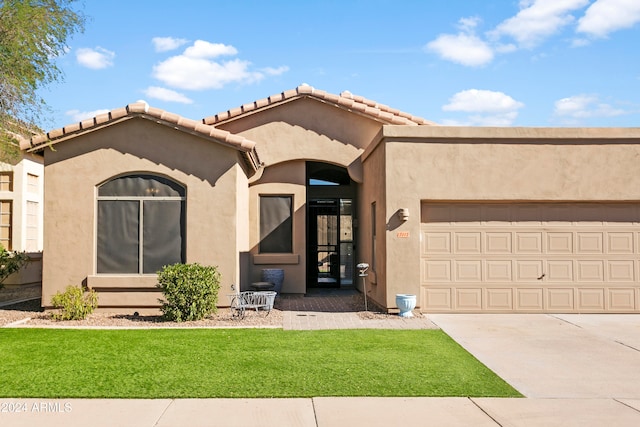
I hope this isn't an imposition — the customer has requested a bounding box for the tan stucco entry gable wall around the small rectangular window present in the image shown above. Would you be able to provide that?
[222,98,381,293]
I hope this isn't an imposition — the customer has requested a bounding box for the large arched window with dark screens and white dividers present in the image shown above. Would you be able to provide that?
[96,174,185,274]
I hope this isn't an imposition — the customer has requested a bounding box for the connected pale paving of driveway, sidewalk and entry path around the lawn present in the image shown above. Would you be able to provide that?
[0,297,640,427]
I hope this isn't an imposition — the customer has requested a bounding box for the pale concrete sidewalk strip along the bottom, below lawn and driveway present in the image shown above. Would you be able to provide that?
[0,397,640,427]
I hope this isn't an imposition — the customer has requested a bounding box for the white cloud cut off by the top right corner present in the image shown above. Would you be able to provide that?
[577,0,640,37]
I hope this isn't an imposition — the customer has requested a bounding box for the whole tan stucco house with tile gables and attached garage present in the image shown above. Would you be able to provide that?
[22,85,640,313]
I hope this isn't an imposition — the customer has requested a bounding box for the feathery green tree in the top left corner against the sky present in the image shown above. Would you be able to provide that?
[0,0,85,162]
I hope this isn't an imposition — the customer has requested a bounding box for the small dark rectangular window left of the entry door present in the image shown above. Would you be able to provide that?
[259,196,293,253]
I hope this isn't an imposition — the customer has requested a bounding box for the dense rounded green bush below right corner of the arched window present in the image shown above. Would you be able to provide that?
[158,263,220,322]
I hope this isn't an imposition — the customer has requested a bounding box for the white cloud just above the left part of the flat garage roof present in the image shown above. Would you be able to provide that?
[442,89,524,126]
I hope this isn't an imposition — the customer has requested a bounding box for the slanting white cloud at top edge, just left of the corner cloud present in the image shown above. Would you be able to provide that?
[489,0,592,48]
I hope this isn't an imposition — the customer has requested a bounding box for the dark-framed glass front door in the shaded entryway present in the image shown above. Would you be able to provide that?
[307,199,354,287]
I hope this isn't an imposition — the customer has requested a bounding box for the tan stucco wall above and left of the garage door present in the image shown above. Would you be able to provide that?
[378,127,640,307]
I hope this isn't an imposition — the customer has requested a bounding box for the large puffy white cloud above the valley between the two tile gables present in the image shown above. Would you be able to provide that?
[153,40,289,90]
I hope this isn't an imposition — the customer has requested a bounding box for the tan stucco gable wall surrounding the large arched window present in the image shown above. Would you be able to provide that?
[43,118,246,307]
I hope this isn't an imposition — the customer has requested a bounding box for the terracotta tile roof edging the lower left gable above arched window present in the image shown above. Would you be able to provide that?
[20,102,261,171]
